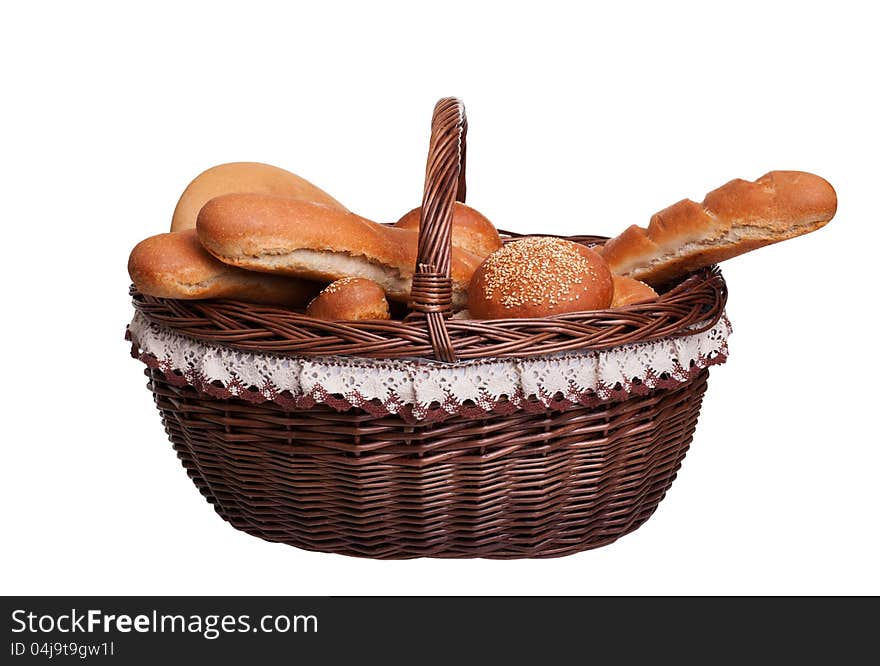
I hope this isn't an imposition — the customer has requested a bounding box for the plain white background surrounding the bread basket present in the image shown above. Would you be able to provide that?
[0,0,880,595]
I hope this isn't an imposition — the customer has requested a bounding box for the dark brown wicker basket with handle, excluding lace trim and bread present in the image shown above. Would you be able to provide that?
[125,99,727,558]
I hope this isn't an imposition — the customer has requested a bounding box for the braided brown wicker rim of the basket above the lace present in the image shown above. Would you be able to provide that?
[133,262,727,360]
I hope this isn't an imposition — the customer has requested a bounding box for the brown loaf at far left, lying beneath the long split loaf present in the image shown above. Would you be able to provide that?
[128,229,320,307]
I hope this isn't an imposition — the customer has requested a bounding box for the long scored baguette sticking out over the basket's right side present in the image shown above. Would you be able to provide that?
[600,171,837,284]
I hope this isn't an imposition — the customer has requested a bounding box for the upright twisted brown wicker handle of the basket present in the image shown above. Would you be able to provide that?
[409,97,467,362]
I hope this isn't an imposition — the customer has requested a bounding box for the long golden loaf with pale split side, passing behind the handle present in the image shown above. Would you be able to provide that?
[197,194,480,309]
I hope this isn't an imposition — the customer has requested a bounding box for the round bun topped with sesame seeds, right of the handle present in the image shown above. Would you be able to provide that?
[468,237,613,319]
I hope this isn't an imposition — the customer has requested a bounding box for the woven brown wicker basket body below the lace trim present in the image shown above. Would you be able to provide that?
[147,370,708,558]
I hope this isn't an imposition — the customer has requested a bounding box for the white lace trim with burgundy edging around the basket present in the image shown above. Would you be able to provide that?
[129,313,731,419]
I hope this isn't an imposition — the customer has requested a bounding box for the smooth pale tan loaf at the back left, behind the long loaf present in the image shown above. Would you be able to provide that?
[171,162,345,231]
